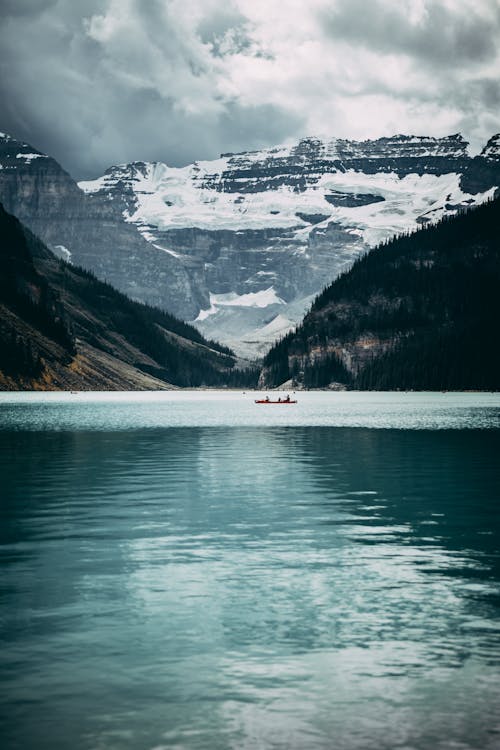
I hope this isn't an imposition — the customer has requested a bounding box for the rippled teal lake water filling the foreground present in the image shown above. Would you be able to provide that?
[0,391,500,750]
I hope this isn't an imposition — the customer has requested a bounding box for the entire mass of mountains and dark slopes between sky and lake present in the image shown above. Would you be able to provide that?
[0,134,500,389]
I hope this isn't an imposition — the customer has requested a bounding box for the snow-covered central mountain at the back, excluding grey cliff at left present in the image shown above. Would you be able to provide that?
[79,135,498,354]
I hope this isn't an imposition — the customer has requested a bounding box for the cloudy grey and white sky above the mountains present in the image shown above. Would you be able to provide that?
[0,0,500,179]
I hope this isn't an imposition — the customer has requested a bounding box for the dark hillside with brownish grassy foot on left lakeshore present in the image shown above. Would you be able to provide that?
[0,206,255,390]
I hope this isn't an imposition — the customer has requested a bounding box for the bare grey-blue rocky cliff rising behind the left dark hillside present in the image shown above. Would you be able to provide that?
[0,133,205,318]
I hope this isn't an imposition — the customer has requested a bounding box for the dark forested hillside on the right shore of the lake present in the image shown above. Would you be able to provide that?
[261,198,500,390]
